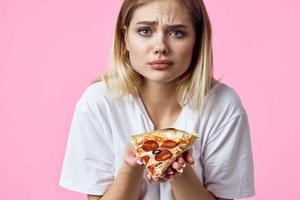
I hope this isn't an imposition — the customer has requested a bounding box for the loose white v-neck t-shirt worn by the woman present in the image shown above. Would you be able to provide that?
[60,82,255,200]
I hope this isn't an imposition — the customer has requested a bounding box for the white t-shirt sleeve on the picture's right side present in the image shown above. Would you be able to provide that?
[202,112,255,199]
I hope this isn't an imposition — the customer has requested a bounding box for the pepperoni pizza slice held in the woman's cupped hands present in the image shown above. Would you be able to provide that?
[131,128,198,179]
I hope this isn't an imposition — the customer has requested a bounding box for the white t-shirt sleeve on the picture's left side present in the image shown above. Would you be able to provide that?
[59,97,114,195]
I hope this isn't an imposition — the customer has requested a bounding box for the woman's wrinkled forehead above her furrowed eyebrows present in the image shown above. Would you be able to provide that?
[130,0,192,26]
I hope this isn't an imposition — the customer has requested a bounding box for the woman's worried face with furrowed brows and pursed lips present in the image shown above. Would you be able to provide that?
[125,0,195,83]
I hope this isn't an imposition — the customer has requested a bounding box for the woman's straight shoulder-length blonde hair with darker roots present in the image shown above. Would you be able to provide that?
[93,0,214,110]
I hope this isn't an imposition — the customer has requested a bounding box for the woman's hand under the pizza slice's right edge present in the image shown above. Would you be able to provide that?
[147,149,195,182]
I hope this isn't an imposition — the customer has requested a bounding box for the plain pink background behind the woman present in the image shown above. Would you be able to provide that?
[0,0,300,200]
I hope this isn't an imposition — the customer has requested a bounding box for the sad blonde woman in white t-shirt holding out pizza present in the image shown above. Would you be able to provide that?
[60,0,255,200]
